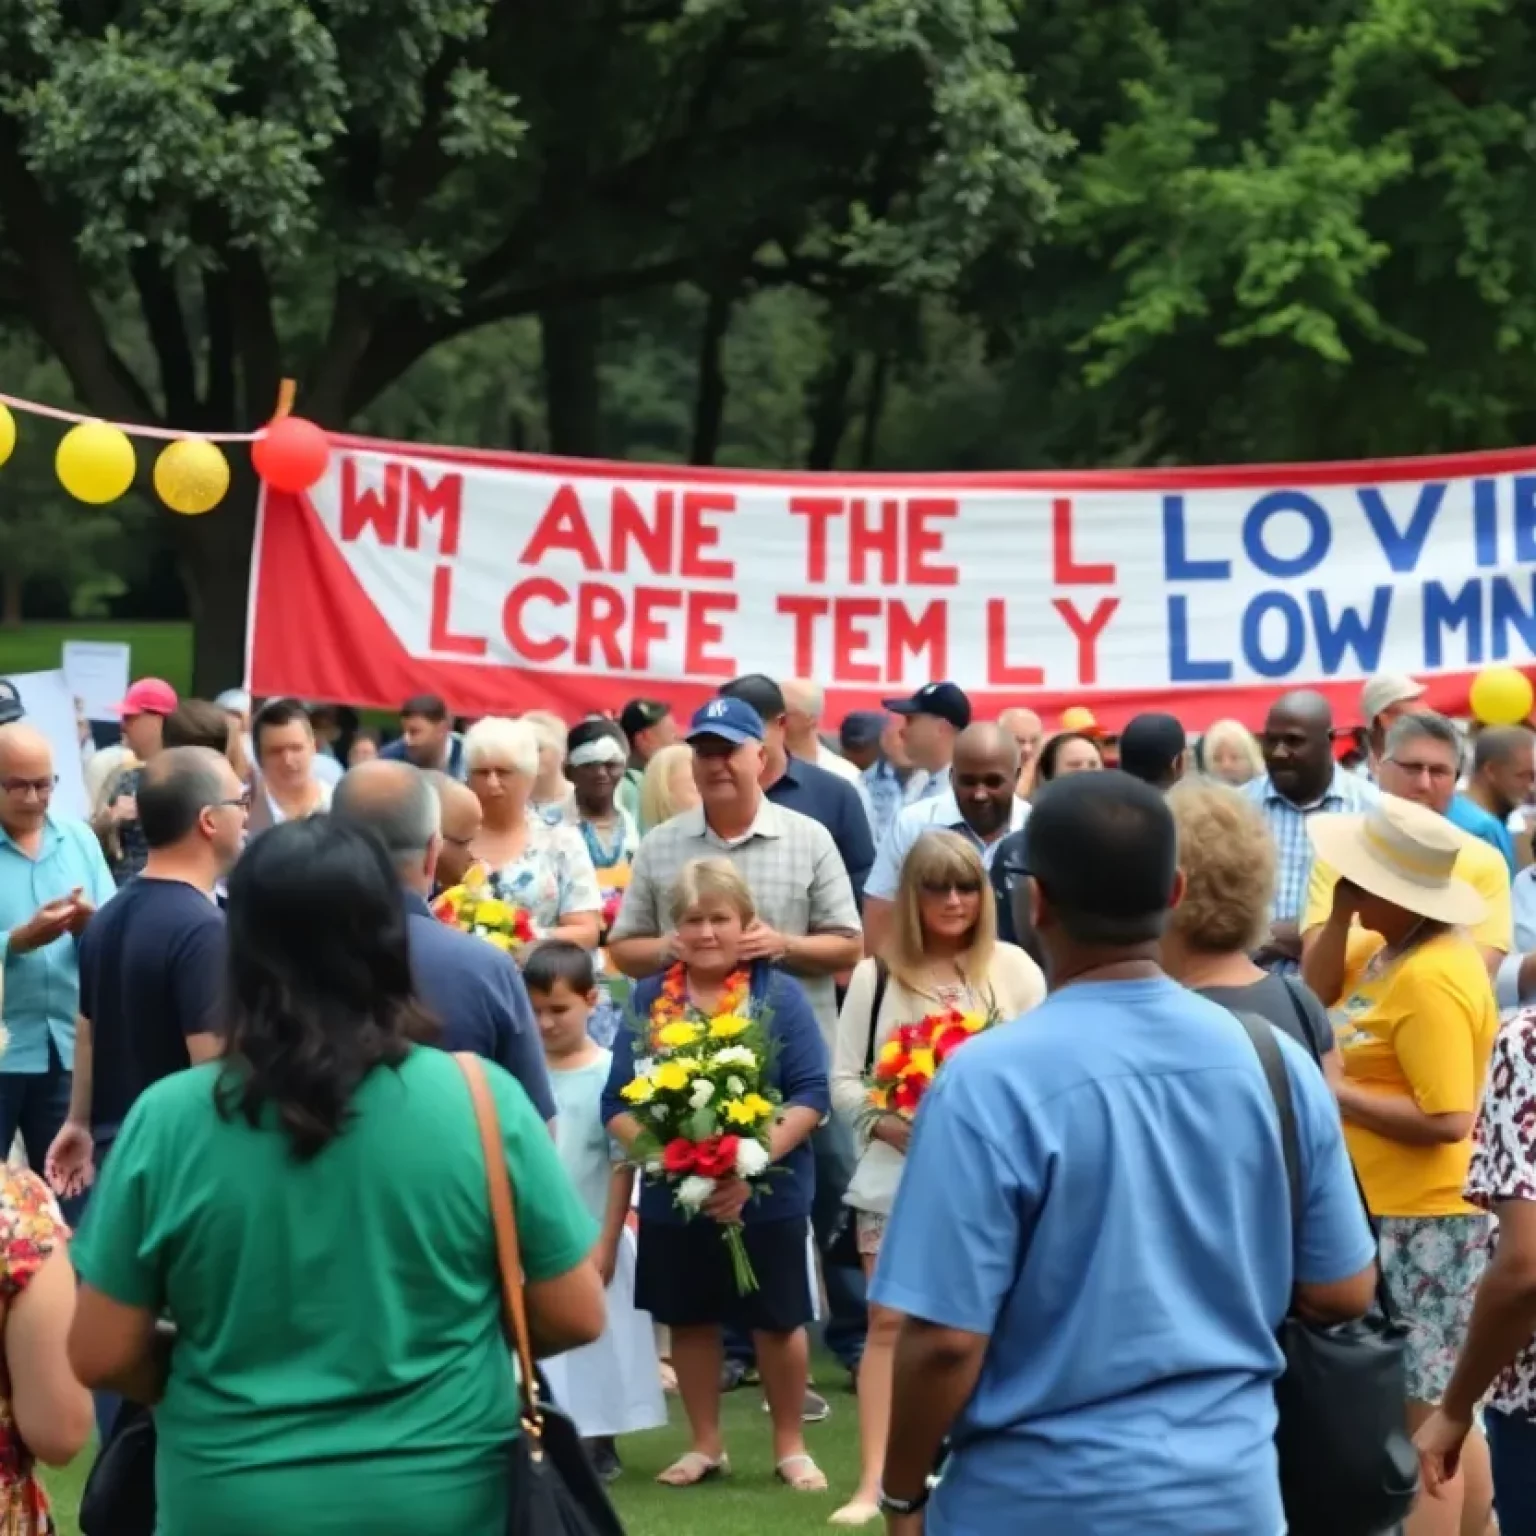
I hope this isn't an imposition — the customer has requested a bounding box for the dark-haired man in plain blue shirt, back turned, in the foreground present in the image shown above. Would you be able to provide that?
[871,771,1375,1536]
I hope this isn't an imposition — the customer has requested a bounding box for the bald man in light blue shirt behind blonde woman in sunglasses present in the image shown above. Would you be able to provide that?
[863,725,1029,954]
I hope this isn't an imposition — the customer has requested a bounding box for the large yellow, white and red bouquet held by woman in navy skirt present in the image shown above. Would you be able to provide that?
[621,965,782,1296]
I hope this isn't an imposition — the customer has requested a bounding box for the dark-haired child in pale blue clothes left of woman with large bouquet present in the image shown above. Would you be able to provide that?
[522,938,667,1481]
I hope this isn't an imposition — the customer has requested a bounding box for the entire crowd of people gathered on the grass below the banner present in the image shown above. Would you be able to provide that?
[0,663,1536,1536]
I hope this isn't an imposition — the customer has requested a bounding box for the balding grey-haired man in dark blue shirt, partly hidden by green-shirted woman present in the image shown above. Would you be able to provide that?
[330,757,554,1123]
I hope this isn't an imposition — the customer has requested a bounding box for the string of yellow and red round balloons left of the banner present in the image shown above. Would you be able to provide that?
[0,379,330,518]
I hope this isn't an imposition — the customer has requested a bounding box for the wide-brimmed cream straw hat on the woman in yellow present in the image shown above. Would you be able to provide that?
[1307,794,1487,926]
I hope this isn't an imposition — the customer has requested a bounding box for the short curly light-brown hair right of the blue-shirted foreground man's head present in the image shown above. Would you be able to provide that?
[1167,779,1275,954]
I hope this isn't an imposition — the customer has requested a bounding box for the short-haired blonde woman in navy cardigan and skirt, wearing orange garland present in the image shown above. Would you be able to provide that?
[602,859,829,1493]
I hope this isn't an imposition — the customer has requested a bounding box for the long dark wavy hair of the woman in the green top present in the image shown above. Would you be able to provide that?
[215,816,436,1161]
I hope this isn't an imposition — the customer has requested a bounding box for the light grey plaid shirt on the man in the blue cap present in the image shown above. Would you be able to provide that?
[608,797,862,1041]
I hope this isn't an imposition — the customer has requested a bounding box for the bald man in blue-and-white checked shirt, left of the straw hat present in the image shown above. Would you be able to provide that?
[1243,688,1378,974]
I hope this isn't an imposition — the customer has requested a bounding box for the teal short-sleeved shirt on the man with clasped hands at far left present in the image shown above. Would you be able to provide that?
[0,813,117,1074]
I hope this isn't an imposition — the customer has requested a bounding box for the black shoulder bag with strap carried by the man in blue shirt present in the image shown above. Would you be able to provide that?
[1236,1014,1419,1536]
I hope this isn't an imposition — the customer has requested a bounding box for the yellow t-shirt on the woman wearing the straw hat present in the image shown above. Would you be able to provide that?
[1329,927,1499,1217]
